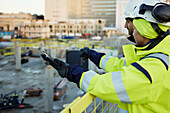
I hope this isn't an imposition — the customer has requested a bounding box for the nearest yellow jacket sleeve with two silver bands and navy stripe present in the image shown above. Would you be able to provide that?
[79,58,167,104]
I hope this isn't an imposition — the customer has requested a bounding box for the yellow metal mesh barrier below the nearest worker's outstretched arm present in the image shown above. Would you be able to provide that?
[61,93,118,113]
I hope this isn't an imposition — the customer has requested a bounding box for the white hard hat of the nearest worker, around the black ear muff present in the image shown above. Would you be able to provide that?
[131,0,170,26]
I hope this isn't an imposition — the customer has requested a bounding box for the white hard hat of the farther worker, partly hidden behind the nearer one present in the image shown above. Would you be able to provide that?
[123,0,143,18]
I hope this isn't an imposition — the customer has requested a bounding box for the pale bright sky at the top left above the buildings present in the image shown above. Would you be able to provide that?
[0,0,45,15]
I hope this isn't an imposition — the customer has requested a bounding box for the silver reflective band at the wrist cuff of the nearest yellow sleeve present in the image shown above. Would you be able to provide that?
[81,71,97,92]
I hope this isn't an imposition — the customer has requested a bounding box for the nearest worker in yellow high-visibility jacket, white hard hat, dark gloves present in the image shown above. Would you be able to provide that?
[40,0,170,113]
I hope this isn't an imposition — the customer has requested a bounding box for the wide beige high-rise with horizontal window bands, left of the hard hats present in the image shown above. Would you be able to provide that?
[45,0,116,26]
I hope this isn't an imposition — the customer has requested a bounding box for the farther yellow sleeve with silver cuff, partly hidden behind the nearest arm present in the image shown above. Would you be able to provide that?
[99,55,126,72]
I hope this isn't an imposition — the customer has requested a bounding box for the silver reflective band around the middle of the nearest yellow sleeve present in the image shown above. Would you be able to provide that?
[112,71,132,104]
